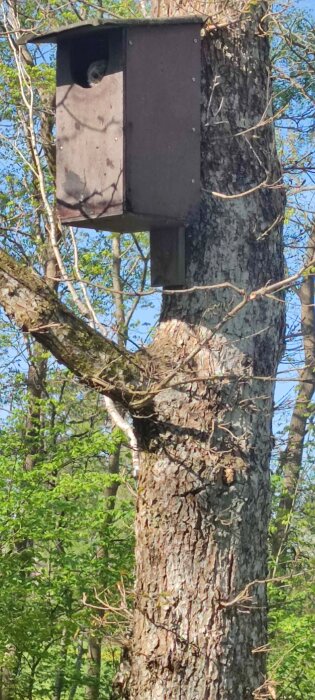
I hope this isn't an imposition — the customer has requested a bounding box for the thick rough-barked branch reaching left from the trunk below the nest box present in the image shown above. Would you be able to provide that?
[0,251,140,405]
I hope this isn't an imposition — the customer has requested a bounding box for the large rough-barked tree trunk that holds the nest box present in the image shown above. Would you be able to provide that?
[128,2,284,700]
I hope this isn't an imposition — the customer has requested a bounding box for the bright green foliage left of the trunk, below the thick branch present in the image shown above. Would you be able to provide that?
[0,380,133,698]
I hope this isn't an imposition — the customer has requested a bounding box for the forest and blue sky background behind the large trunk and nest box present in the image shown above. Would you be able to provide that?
[0,0,315,700]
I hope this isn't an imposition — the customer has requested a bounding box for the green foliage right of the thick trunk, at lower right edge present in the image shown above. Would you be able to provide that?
[269,468,315,700]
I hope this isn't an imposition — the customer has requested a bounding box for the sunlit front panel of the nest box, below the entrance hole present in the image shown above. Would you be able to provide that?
[56,34,124,228]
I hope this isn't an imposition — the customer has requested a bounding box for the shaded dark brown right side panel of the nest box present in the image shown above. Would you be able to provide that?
[125,24,201,225]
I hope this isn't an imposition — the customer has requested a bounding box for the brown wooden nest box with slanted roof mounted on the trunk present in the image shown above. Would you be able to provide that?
[25,17,202,284]
